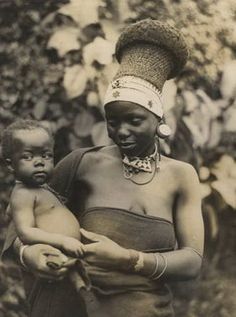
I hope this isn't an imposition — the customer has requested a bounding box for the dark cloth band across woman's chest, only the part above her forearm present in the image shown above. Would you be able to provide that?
[80,207,176,252]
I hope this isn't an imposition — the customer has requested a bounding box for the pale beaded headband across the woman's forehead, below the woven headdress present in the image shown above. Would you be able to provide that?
[104,76,163,118]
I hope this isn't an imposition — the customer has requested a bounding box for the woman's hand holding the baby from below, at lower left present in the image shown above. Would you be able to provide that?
[23,244,76,280]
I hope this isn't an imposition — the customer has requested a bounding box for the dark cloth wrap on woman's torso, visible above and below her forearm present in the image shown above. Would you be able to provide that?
[80,207,176,317]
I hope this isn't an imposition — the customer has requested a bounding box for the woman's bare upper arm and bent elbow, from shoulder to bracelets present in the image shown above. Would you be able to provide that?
[159,163,204,280]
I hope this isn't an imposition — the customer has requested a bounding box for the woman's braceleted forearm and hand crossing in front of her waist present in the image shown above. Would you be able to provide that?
[81,229,202,281]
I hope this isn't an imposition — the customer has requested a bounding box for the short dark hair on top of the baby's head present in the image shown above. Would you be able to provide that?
[2,119,53,159]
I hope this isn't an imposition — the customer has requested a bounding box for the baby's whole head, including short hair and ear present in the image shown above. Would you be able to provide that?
[2,120,54,187]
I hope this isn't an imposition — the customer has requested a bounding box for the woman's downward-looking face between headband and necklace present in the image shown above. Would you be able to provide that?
[105,101,158,157]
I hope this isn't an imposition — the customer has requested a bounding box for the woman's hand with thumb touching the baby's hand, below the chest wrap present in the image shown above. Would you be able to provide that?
[80,229,130,269]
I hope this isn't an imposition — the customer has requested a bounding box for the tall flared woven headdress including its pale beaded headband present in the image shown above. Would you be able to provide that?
[104,19,188,118]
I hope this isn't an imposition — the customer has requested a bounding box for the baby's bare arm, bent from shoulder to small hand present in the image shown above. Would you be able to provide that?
[10,188,83,256]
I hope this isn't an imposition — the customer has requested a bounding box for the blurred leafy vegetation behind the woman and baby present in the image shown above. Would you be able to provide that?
[0,0,236,317]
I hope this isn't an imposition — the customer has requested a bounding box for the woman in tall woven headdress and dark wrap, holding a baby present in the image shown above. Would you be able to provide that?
[1,19,203,317]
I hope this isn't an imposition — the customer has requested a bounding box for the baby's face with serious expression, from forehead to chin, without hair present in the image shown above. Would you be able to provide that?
[11,128,53,187]
